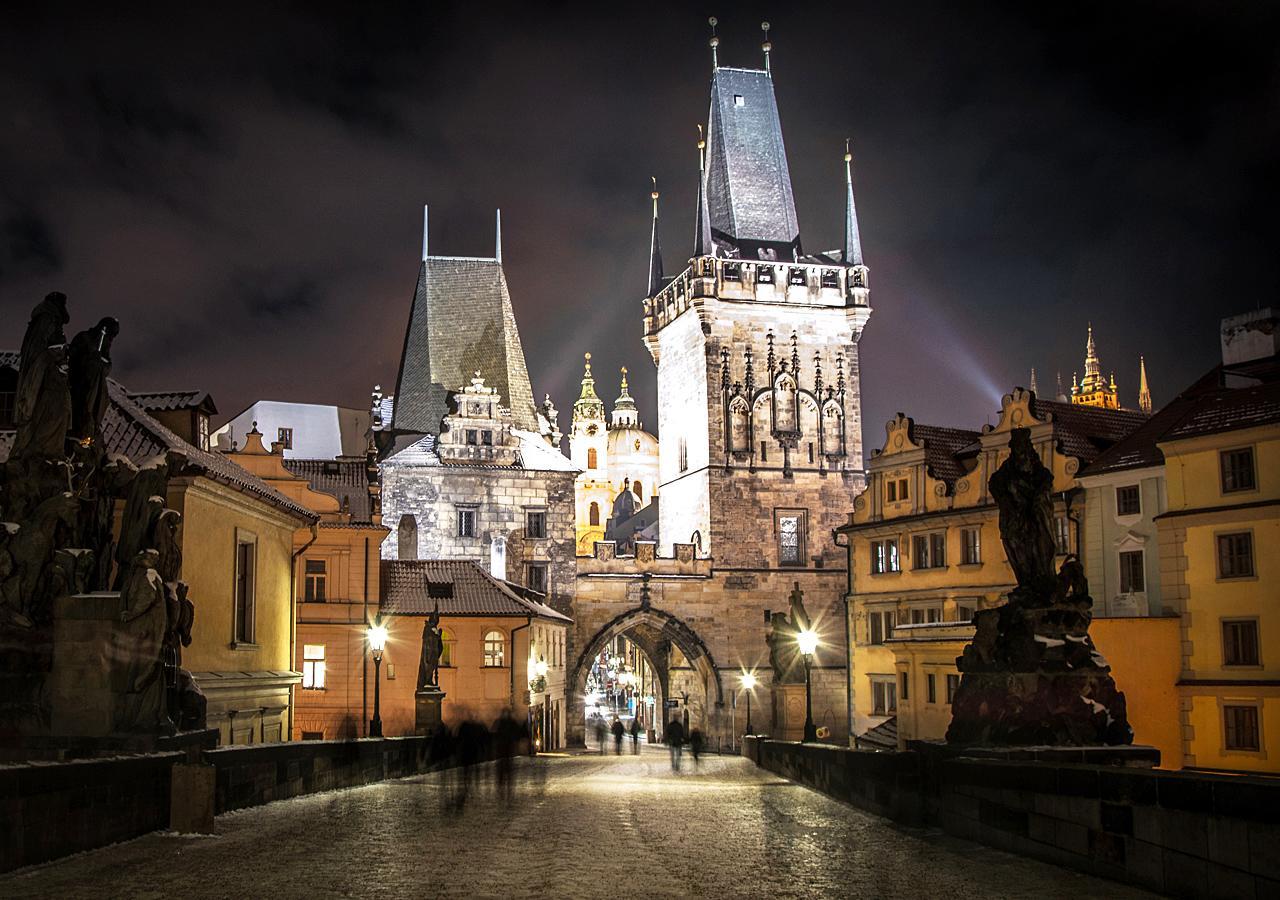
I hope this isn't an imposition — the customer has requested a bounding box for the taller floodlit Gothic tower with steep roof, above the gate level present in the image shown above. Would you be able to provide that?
[644,45,872,568]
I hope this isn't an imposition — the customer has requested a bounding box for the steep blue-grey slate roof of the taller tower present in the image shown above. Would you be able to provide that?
[707,67,800,259]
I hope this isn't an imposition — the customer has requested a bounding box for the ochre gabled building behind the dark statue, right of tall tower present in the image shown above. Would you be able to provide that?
[836,388,1172,741]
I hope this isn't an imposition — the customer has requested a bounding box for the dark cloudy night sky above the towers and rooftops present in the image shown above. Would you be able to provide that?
[0,1,1280,458]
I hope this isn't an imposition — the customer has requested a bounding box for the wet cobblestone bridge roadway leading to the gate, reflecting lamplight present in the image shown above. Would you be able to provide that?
[0,750,1144,900]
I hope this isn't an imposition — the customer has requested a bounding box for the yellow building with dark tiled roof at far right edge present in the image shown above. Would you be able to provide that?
[1157,310,1280,772]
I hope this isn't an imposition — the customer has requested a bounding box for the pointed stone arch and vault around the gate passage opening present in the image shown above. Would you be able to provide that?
[567,606,724,745]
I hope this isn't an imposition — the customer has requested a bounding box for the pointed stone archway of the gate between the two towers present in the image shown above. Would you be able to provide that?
[567,606,724,744]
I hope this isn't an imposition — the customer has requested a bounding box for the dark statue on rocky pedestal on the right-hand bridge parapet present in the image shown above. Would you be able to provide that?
[947,429,1133,746]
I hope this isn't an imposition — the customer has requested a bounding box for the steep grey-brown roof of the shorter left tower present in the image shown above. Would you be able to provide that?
[392,256,538,434]
